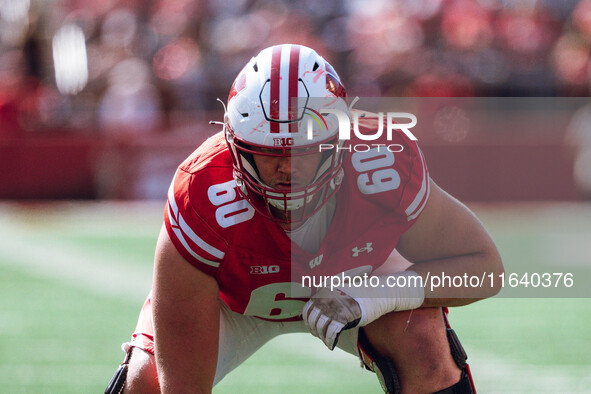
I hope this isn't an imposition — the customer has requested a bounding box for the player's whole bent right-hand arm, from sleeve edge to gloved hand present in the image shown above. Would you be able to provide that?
[302,181,503,350]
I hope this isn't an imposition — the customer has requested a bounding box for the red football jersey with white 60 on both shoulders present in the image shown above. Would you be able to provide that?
[164,115,429,320]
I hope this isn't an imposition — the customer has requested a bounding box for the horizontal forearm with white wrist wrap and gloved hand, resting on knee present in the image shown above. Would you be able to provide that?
[302,248,503,350]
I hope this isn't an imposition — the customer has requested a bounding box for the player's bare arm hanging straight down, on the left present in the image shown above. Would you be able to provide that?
[152,226,220,393]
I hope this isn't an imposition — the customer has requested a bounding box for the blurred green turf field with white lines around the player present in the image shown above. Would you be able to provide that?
[0,203,591,393]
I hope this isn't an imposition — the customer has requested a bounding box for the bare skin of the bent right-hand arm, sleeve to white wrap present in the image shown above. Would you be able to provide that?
[396,181,503,307]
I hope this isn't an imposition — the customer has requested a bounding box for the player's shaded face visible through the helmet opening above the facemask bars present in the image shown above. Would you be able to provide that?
[253,149,322,191]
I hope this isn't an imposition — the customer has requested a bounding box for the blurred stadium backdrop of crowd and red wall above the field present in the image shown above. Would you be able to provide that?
[0,0,591,201]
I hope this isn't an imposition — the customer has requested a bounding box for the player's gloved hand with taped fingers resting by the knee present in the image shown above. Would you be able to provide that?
[302,289,361,350]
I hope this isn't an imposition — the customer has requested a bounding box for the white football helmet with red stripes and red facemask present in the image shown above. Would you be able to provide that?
[224,44,348,222]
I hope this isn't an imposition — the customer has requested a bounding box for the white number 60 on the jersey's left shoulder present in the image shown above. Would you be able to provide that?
[207,179,254,228]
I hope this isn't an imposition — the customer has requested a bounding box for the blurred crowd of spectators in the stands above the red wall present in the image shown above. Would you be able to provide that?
[0,0,591,135]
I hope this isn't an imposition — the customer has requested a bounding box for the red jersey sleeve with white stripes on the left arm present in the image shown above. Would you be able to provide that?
[164,168,226,276]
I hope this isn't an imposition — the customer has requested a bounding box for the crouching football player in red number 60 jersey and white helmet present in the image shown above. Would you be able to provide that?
[107,44,503,393]
